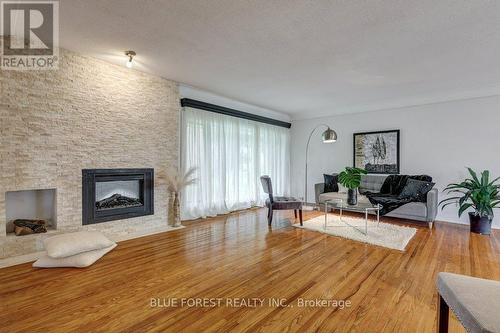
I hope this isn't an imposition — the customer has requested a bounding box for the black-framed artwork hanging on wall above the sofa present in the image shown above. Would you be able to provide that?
[354,130,399,174]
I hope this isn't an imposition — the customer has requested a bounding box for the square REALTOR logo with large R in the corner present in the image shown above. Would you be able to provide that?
[0,1,59,70]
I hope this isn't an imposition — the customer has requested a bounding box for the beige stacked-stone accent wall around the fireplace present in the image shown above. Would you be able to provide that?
[0,49,180,258]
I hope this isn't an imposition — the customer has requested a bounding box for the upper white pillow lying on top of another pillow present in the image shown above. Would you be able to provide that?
[43,231,115,258]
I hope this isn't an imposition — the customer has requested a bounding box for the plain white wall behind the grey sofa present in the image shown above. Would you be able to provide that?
[291,96,500,228]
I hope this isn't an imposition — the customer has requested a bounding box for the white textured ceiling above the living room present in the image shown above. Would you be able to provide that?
[60,0,500,119]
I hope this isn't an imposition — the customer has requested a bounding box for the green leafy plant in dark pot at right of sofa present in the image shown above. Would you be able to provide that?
[439,168,500,235]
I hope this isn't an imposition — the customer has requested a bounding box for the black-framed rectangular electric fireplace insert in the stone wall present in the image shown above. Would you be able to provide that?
[82,169,154,224]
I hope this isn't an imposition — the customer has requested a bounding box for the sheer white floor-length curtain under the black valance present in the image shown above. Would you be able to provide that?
[181,108,290,220]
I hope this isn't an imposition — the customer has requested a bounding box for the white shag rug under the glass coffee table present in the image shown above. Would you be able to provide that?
[293,214,417,251]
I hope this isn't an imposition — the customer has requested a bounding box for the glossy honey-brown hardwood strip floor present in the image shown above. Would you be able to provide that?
[0,209,500,332]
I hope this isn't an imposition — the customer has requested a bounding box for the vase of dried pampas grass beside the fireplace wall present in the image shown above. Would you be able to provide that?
[165,167,197,227]
